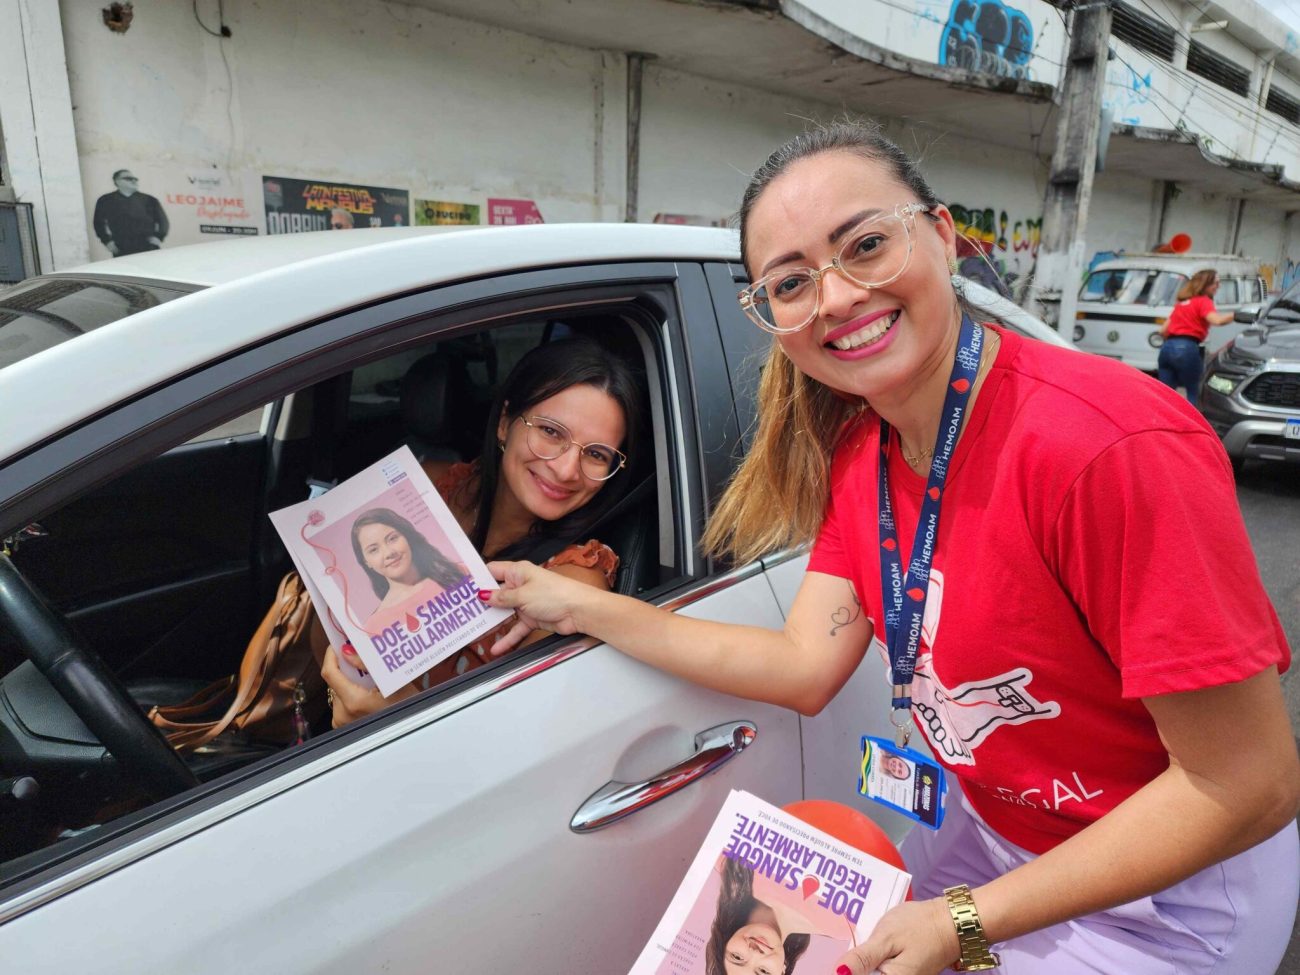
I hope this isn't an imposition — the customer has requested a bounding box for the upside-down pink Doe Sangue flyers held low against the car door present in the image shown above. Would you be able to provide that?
[631,790,911,975]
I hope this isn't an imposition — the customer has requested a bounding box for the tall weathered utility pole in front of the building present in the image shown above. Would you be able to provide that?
[1032,0,1110,337]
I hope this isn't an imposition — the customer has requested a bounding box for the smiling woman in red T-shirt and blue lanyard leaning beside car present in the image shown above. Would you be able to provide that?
[485,124,1300,975]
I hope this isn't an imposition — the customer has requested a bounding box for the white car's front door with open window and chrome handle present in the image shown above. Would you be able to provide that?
[0,264,802,974]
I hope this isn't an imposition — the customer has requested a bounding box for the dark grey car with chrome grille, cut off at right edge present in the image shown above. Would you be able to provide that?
[1200,283,1300,467]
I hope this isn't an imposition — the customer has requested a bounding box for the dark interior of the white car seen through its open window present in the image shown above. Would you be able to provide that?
[0,304,689,874]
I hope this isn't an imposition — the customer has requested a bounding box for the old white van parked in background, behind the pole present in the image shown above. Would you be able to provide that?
[1062,254,1265,372]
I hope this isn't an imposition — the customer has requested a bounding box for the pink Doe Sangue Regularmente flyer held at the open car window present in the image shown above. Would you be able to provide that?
[270,447,510,697]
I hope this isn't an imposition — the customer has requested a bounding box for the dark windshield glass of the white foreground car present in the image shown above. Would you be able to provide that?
[0,277,187,369]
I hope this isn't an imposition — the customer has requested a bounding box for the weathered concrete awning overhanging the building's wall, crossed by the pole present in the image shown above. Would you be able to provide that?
[413,0,1300,209]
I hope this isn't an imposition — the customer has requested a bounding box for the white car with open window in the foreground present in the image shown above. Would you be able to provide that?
[0,224,1060,975]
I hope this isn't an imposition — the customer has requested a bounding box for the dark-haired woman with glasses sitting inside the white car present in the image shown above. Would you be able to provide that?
[321,338,641,728]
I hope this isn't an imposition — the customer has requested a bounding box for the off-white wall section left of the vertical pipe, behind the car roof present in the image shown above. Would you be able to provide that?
[62,0,625,256]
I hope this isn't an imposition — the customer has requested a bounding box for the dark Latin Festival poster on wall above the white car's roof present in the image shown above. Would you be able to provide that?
[261,176,411,234]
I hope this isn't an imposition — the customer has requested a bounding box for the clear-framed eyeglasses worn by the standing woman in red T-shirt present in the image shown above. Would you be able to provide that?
[737,203,931,335]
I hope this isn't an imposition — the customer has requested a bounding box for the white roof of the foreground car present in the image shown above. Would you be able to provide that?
[0,224,740,463]
